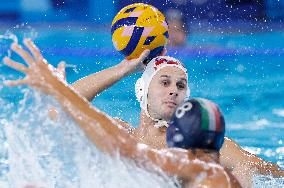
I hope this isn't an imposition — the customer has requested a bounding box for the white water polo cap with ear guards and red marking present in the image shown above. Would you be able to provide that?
[135,56,190,127]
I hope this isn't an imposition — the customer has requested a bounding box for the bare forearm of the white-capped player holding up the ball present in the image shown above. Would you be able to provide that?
[72,63,129,101]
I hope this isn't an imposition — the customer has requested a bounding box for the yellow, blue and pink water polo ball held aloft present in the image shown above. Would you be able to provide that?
[111,3,169,60]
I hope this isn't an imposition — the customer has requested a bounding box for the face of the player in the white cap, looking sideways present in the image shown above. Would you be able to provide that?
[148,67,187,121]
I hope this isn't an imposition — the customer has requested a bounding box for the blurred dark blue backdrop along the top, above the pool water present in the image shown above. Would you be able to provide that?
[0,0,284,24]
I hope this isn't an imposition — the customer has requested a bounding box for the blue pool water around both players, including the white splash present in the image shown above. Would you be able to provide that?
[0,25,284,187]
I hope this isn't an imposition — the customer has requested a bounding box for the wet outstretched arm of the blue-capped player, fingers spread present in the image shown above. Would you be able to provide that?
[4,40,238,187]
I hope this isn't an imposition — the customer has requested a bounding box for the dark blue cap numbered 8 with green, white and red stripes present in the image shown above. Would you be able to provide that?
[167,98,225,151]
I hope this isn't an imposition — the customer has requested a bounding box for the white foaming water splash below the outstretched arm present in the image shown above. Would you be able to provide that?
[0,88,178,188]
